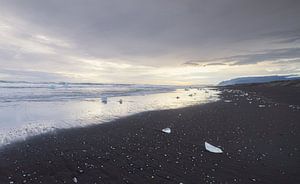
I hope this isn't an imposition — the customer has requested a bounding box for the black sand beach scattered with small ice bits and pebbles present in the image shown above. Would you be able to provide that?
[0,81,300,184]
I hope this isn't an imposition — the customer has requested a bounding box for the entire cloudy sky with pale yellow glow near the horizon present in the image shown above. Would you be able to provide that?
[0,0,300,85]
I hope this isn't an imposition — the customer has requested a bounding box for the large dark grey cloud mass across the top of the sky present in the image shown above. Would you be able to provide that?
[1,0,300,63]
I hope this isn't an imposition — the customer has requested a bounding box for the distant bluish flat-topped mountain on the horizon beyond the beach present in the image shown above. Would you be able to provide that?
[218,75,300,86]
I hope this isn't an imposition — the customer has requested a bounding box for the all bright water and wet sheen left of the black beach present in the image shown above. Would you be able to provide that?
[0,82,219,145]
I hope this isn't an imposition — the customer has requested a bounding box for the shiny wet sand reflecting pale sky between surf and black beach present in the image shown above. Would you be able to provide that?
[0,89,218,144]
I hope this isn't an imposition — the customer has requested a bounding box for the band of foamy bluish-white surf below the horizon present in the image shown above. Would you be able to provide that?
[0,81,176,103]
